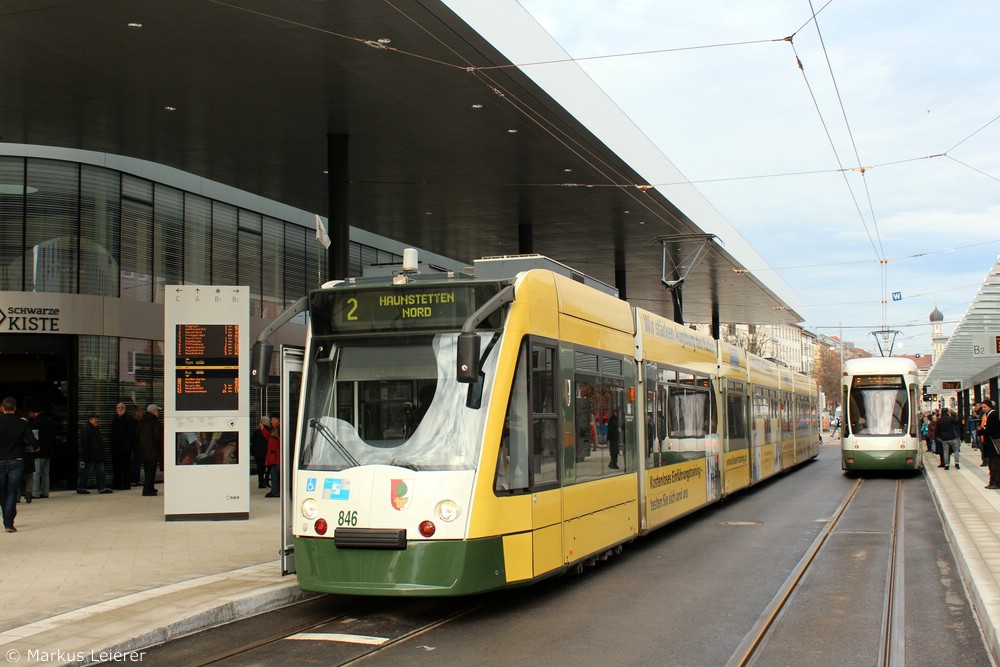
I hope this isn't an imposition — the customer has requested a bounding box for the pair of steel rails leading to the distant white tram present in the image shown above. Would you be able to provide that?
[726,479,905,667]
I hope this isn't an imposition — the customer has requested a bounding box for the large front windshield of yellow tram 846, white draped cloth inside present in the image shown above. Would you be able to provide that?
[299,333,499,470]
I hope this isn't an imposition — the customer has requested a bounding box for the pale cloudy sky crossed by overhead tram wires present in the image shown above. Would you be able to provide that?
[519,0,1000,354]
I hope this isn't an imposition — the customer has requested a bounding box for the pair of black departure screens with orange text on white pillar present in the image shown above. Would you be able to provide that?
[175,324,240,411]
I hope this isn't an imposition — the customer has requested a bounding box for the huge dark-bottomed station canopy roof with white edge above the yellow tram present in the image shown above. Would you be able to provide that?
[0,0,802,324]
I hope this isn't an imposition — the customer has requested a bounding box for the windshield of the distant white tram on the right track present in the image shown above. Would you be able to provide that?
[848,375,910,435]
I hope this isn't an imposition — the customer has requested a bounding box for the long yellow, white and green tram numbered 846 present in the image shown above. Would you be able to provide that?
[293,256,819,596]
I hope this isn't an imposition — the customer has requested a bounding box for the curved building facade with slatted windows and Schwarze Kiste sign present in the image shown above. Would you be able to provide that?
[0,144,447,488]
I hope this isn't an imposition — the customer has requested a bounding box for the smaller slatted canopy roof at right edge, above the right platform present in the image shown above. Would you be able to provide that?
[924,259,1000,392]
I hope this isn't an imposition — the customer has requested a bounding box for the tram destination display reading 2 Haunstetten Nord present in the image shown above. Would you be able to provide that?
[310,283,499,336]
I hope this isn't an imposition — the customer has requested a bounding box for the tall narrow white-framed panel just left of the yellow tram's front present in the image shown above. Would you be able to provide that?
[280,345,304,575]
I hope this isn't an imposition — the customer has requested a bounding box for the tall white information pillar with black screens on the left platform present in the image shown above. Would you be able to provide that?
[161,285,250,521]
